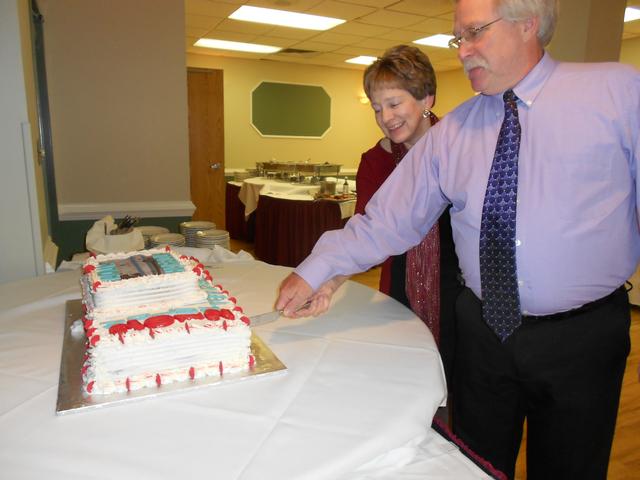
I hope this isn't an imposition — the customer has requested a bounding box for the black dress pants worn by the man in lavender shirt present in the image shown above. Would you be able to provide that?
[453,288,630,480]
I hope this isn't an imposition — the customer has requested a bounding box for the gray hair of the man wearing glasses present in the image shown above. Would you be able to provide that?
[456,0,559,47]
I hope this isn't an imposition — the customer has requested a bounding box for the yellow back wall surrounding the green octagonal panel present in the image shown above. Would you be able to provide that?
[187,54,473,169]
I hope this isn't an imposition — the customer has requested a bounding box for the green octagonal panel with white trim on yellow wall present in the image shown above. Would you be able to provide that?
[251,82,331,138]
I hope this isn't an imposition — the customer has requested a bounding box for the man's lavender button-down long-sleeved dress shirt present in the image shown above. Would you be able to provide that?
[296,53,640,315]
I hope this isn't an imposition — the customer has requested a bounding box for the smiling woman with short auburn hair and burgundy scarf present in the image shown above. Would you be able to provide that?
[356,45,461,384]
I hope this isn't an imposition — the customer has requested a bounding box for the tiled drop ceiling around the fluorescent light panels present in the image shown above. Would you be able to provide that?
[185,0,640,71]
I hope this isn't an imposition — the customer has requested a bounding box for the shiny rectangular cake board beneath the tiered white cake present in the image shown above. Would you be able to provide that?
[56,299,287,415]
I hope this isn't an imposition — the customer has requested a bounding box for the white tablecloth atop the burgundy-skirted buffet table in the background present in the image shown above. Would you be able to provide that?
[233,177,356,219]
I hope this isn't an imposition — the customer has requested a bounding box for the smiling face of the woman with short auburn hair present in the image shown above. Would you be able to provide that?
[371,87,433,146]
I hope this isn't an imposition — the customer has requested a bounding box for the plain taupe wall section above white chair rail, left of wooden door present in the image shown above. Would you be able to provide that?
[38,0,189,204]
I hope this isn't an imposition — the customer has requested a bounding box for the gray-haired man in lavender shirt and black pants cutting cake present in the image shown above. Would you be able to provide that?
[276,0,640,480]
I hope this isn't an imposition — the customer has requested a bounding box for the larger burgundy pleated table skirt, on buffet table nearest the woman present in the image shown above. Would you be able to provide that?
[255,195,348,267]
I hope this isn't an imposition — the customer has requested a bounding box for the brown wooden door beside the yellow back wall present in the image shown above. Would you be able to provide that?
[187,68,225,228]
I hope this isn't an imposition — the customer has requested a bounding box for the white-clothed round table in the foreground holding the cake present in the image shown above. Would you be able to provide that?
[0,261,488,480]
